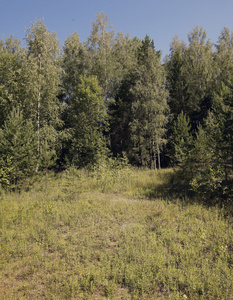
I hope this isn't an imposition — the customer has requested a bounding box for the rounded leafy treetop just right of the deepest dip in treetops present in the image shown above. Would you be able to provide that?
[166,26,217,124]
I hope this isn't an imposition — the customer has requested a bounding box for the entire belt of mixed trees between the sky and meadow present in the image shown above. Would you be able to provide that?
[0,13,233,203]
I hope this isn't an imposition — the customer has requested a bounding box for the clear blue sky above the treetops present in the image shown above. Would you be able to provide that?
[0,0,233,56]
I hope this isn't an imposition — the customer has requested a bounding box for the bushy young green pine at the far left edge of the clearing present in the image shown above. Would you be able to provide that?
[0,108,36,186]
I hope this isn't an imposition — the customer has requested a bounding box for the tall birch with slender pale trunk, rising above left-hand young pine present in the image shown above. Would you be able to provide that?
[24,20,61,170]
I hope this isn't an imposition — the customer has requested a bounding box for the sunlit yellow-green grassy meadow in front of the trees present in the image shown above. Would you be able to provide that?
[0,167,233,300]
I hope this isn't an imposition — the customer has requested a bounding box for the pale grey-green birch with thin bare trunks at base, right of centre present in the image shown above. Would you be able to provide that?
[125,37,169,169]
